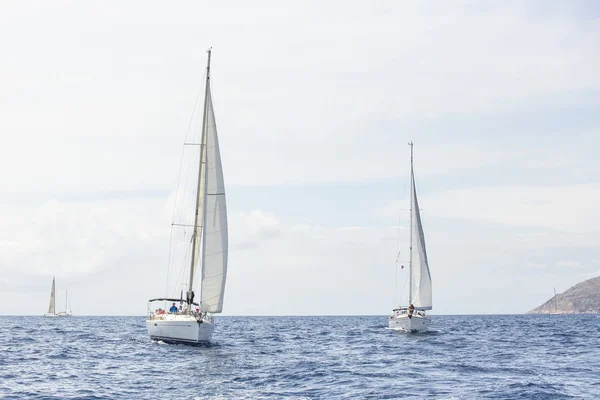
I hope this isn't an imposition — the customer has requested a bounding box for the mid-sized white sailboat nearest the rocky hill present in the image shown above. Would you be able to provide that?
[389,142,432,332]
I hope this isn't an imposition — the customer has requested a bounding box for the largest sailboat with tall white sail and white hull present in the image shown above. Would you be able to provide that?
[146,49,228,344]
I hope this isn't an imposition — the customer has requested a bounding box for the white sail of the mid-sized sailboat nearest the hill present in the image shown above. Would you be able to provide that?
[410,172,432,310]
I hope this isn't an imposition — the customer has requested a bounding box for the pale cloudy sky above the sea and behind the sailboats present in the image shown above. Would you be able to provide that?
[0,1,600,315]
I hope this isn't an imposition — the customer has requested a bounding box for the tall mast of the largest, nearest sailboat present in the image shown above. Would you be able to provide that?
[186,49,216,313]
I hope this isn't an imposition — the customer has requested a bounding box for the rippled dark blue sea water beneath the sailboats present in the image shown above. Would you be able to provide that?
[0,315,600,399]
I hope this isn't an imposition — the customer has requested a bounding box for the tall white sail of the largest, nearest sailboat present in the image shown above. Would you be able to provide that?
[201,85,228,313]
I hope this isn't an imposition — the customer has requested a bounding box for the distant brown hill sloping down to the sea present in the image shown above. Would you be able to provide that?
[527,276,600,314]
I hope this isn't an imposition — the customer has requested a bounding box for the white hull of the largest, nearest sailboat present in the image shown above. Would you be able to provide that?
[146,314,215,344]
